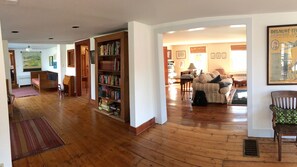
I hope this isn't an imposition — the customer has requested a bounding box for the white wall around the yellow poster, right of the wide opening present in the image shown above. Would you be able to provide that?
[249,12,297,137]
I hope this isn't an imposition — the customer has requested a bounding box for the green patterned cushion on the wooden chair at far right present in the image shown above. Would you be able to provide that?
[271,106,297,124]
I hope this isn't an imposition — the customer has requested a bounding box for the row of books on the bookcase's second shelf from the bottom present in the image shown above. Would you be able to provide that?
[98,85,121,101]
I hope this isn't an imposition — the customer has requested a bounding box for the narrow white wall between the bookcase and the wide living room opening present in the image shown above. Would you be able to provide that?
[128,21,156,127]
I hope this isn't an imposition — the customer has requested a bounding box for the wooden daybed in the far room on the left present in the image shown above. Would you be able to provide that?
[31,71,58,92]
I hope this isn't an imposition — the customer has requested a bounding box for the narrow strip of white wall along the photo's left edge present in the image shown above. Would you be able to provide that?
[0,23,12,167]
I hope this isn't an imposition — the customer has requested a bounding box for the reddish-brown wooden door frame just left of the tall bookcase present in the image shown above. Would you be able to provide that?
[75,39,91,96]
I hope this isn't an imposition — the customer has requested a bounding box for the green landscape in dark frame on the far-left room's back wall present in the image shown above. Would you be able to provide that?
[21,51,41,72]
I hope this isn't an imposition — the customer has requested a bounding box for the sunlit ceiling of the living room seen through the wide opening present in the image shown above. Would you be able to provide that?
[163,25,246,46]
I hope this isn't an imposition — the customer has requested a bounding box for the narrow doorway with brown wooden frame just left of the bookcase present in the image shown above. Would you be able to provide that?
[75,39,91,99]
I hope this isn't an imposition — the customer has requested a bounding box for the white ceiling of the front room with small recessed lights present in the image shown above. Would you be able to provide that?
[0,0,297,43]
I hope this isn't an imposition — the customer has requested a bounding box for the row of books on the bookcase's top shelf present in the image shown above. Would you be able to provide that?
[99,41,121,56]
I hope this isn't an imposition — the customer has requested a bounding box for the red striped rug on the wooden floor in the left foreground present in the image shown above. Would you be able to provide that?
[10,118,64,160]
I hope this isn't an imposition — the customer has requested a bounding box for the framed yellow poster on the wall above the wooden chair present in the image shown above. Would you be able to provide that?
[267,24,297,85]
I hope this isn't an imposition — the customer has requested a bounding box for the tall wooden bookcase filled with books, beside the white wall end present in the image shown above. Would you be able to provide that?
[95,32,130,122]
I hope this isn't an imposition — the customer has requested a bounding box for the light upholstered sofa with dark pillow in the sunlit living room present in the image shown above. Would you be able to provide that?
[192,71,233,104]
